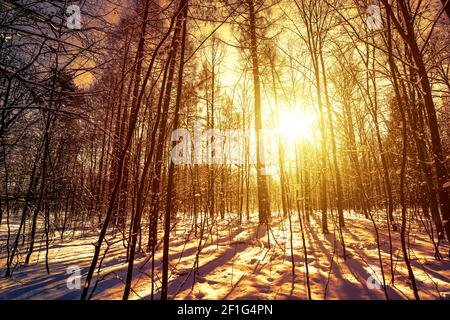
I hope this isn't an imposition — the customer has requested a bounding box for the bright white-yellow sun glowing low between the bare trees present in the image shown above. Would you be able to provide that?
[278,109,317,142]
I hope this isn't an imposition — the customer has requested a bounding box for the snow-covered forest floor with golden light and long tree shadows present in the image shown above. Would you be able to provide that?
[0,213,450,299]
